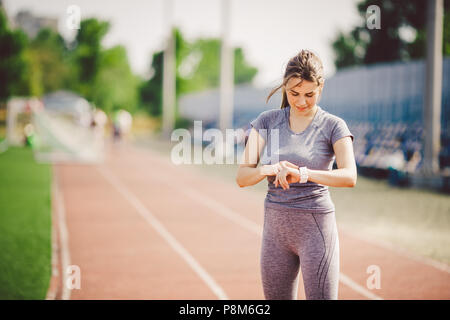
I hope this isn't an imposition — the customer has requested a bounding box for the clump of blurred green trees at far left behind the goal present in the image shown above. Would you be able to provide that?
[0,10,139,112]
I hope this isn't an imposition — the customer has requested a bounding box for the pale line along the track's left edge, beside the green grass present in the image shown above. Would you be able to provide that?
[53,168,71,300]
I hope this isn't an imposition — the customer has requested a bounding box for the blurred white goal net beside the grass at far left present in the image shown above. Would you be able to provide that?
[7,95,104,163]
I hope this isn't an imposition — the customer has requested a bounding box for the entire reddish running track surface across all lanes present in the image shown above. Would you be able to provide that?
[57,143,450,299]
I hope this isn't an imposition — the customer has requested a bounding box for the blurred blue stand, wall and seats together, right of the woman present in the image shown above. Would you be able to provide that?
[320,58,450,172]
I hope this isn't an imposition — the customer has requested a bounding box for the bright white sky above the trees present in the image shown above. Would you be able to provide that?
[3,0,360,87]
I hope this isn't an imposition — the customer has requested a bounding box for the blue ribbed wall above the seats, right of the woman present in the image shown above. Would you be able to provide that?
[320,58,450,133]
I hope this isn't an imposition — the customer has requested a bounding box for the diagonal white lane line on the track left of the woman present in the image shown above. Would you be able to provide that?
[97,167,229,300]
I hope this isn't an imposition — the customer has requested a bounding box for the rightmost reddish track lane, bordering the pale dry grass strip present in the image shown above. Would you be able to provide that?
[115,144,450,299]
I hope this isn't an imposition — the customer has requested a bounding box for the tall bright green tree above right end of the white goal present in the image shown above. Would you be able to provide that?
[68,18,139,113]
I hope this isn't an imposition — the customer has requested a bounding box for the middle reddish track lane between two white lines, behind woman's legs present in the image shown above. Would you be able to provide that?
[104,145,367,299]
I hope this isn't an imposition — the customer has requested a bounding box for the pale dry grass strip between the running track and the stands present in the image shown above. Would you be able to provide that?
[136,132,450,264]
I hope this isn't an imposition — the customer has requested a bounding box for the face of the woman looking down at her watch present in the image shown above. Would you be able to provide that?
[285,78,322,116]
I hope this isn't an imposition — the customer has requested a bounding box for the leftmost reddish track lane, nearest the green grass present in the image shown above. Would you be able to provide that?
[57,165,217,300]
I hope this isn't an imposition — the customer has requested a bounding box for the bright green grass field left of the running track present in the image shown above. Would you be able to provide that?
[0,148,51,299]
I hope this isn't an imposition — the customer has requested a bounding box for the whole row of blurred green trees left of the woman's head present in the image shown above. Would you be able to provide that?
[0,10,257,120]
